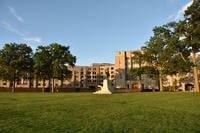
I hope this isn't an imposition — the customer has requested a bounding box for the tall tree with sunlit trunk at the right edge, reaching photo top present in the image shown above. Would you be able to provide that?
[177,0,200,92]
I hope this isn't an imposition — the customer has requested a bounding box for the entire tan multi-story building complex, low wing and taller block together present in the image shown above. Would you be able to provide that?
[0,50,200,90]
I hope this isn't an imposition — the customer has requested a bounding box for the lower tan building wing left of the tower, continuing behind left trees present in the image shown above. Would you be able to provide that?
[0,63,116,88]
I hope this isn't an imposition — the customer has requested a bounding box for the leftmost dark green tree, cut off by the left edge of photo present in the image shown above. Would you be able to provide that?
[0,43,33,92]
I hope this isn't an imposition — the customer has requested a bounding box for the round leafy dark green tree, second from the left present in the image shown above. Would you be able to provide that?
[34,43,76,92]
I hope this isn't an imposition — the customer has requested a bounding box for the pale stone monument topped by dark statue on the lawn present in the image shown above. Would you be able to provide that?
[93,69,113,94]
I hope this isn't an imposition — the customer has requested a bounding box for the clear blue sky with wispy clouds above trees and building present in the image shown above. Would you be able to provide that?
[0,0,192,66]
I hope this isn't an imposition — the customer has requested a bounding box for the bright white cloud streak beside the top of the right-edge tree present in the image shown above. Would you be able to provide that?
[168,0,193,21]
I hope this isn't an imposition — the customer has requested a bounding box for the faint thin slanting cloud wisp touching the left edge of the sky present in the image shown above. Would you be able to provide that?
[0,21,25,36]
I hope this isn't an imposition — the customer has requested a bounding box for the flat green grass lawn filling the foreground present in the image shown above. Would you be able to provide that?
[0,92,200,133]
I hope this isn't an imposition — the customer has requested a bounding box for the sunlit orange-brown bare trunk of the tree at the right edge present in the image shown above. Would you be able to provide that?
[192,51,199,92]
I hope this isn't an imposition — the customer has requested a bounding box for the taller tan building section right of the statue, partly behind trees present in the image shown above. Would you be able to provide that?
[115,50,200,91]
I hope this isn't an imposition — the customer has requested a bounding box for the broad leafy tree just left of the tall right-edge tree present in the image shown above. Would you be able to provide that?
[144,22,193,91]
